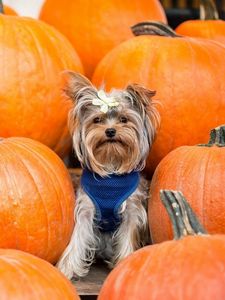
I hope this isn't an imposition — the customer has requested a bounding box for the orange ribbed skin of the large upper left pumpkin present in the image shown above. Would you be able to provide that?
[0,14,82,156]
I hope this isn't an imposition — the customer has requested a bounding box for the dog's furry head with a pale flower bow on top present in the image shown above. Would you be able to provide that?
[65,72,159,176]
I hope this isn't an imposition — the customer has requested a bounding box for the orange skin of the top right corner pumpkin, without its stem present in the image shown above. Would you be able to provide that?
[176,20,225,44]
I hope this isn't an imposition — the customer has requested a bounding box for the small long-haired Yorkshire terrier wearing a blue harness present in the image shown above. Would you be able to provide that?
[57,72,159,279]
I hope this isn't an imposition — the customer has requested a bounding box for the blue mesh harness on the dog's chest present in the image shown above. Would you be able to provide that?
[81,169,140,232]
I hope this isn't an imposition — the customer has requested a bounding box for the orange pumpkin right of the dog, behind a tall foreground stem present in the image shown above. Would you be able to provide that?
[148,126,225,243]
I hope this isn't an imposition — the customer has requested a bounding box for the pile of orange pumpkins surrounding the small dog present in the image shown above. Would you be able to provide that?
[0,0,225,300]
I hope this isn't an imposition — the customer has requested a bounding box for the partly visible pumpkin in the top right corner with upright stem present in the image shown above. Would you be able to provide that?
[176,0,225,44]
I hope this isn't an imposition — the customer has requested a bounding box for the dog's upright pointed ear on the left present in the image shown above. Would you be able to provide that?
[63,71,96,102]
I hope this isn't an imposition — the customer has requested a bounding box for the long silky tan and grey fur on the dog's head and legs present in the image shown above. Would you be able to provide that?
[57,72,159,278]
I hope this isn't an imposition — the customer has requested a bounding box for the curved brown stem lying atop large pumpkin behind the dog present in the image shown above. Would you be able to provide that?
[131,21,180,37]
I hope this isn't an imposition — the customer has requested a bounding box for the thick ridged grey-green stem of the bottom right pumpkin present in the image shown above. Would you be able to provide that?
[160,190,206,240]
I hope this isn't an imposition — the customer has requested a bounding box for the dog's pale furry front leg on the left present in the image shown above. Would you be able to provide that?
[57,190,97,279]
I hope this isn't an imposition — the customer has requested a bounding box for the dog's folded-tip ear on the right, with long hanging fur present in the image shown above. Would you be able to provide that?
[126,83,160,147]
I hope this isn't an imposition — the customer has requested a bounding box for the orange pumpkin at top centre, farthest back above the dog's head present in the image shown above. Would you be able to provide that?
[40,0,166,78]
